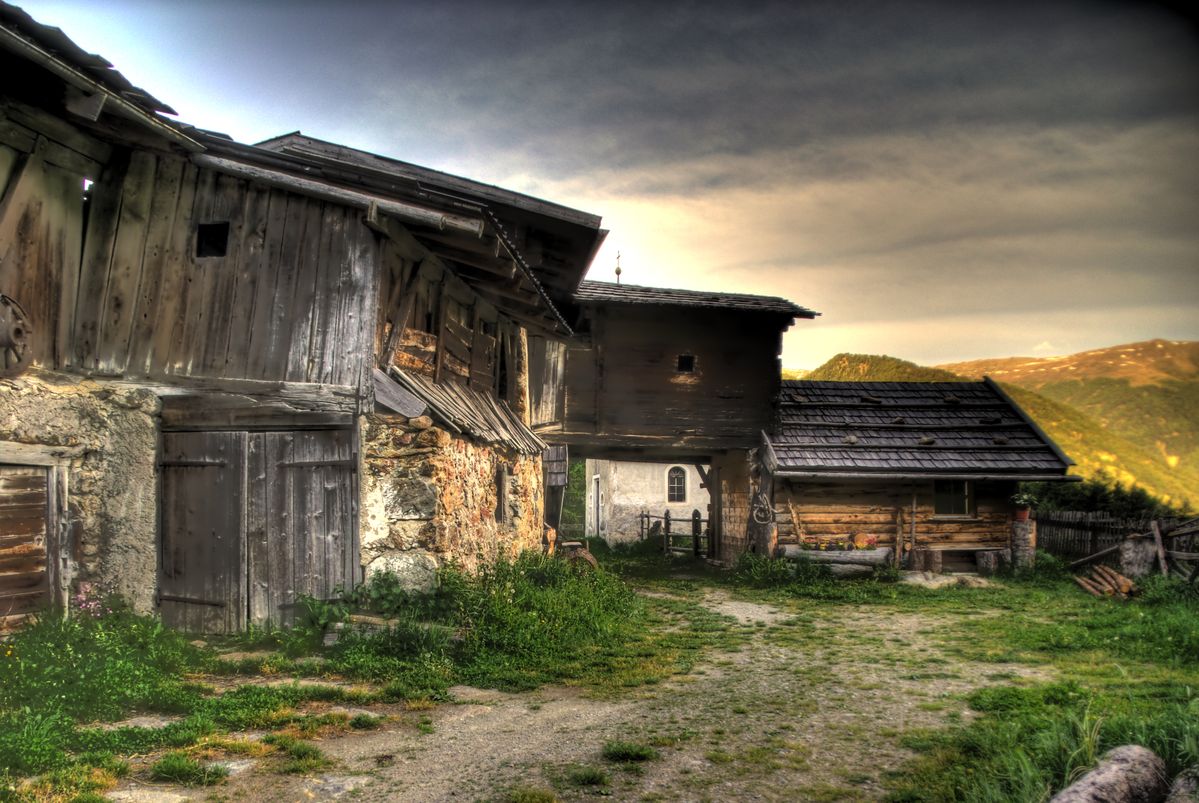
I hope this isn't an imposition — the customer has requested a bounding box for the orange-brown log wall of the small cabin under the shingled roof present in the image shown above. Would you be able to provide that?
[775,479,1014,550]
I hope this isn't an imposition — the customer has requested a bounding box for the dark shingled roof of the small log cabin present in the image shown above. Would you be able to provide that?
[766,379,1073,479]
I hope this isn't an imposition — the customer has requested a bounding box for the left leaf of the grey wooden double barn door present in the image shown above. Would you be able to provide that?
[158,433,247,633]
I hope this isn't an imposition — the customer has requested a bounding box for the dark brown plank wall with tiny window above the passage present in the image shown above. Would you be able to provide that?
[566,304,781,441]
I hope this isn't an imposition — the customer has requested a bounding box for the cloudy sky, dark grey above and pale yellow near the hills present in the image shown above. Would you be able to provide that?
[18,0,1199,368]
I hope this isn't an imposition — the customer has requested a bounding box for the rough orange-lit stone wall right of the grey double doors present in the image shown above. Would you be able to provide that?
[359,415,544,588]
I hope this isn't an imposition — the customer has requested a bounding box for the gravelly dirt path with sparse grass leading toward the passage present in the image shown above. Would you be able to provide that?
[103,590,1035,802]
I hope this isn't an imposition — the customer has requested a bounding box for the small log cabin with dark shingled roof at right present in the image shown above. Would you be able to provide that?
[758,380,1073,570]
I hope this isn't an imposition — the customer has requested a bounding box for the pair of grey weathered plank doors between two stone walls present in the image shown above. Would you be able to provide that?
[158,430,357,633]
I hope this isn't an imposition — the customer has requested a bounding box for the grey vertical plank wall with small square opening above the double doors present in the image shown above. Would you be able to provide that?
[70,151,378,387]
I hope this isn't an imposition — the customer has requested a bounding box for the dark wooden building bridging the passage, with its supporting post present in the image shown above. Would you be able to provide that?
[549,280,818,561]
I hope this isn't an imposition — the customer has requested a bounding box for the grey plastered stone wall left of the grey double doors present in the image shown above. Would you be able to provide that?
[0,372,159,612]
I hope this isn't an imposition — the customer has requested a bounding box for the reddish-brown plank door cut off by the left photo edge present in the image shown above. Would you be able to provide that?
[0,465,50,633]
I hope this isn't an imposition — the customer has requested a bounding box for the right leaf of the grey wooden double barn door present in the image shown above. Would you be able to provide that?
[249,430,357,624]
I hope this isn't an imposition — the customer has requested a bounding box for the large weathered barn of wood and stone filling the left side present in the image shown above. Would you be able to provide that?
[0,4,604,630]
